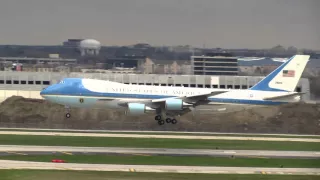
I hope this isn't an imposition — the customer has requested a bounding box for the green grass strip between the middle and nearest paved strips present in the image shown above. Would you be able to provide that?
[0,154,320,168]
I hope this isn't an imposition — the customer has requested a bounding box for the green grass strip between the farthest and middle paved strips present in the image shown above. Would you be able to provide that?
[0,135,320,151]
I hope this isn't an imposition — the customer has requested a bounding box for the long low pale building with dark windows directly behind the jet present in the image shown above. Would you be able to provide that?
[0,71,310,100]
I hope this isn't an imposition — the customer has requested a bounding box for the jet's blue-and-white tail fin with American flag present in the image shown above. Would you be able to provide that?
[250,55,310,92]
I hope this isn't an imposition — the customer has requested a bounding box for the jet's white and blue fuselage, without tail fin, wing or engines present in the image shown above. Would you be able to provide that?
[42,79,300,109]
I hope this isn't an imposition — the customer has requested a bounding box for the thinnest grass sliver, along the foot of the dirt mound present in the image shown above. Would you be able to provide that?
[0,129,320,139]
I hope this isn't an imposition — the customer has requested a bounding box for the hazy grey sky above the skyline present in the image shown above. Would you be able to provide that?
[0,0,320,50]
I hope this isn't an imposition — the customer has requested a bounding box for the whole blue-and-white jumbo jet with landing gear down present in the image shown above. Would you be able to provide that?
[40,55,310,125]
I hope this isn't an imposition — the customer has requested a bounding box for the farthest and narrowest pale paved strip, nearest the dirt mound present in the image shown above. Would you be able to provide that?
[0,131,320,142]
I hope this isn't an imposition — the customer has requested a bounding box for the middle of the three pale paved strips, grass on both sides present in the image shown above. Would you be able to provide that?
[0,145,320,159]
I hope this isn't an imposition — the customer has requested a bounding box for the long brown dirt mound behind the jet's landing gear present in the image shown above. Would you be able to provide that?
[0,96,320,134]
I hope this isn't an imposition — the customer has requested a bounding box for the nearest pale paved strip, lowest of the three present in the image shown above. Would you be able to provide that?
[0,160,320,175]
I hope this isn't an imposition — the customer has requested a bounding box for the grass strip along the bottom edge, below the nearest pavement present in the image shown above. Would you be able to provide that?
[0,170,319,180]
